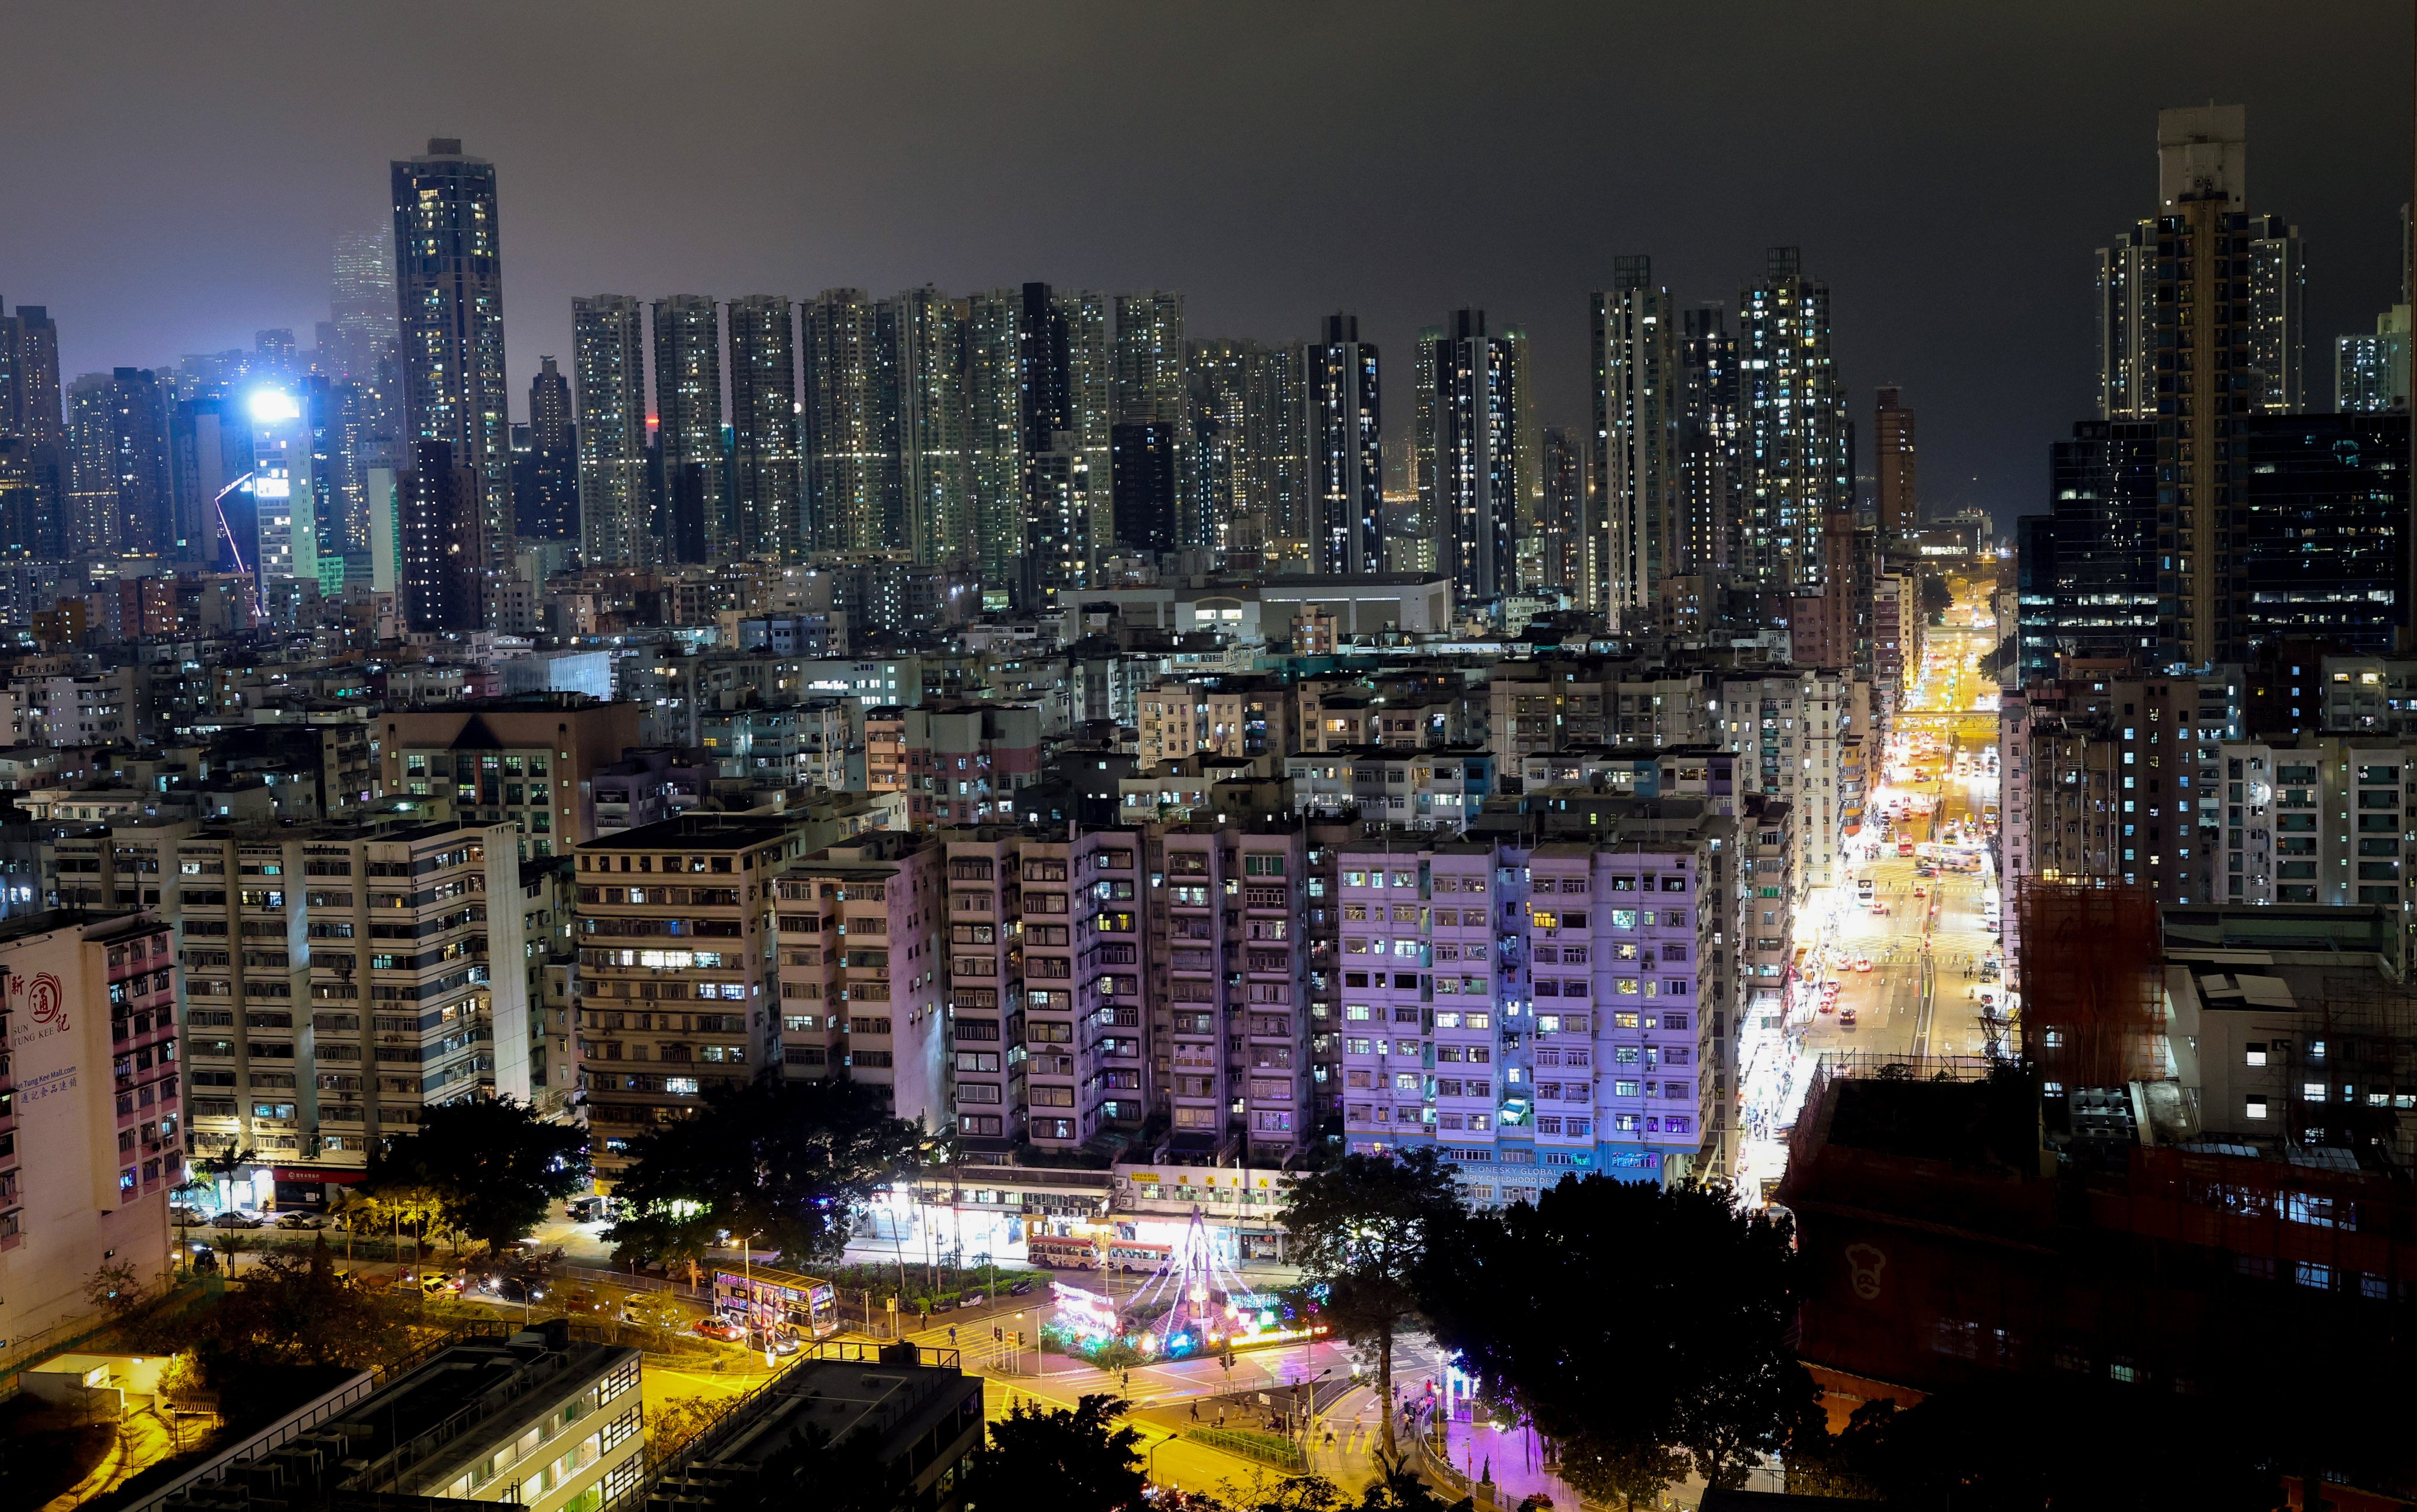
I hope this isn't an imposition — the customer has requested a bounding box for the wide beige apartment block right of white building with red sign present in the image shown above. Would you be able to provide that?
[53,811,524,1203]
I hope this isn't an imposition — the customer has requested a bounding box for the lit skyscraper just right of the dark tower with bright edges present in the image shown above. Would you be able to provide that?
[1417,309,1525,604]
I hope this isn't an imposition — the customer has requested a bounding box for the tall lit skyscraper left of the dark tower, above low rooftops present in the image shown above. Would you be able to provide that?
[1583,256,1685,630]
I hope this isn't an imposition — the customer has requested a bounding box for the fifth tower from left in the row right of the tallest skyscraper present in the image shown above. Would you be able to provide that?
[877,285,979,563]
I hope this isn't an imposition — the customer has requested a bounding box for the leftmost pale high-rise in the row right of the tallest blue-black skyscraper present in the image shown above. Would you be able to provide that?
[570,294,658,568]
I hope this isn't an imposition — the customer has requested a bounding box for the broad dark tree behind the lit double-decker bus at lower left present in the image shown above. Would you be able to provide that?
[604,1077,928,1266]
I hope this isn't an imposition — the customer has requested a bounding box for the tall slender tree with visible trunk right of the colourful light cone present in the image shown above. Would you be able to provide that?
[1283,1147,1462,1457]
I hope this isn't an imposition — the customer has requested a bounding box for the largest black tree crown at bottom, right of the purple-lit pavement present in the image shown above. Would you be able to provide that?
[1419,1176,1817,1495]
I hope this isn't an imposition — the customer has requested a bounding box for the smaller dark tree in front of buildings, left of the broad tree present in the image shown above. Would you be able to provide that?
[367,1097,587,1254]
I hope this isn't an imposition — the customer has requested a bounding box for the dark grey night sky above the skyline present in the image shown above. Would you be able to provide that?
[0,0,2410,522]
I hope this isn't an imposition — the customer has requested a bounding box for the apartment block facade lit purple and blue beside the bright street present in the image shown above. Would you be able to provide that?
[1339,800,1733,1203]
